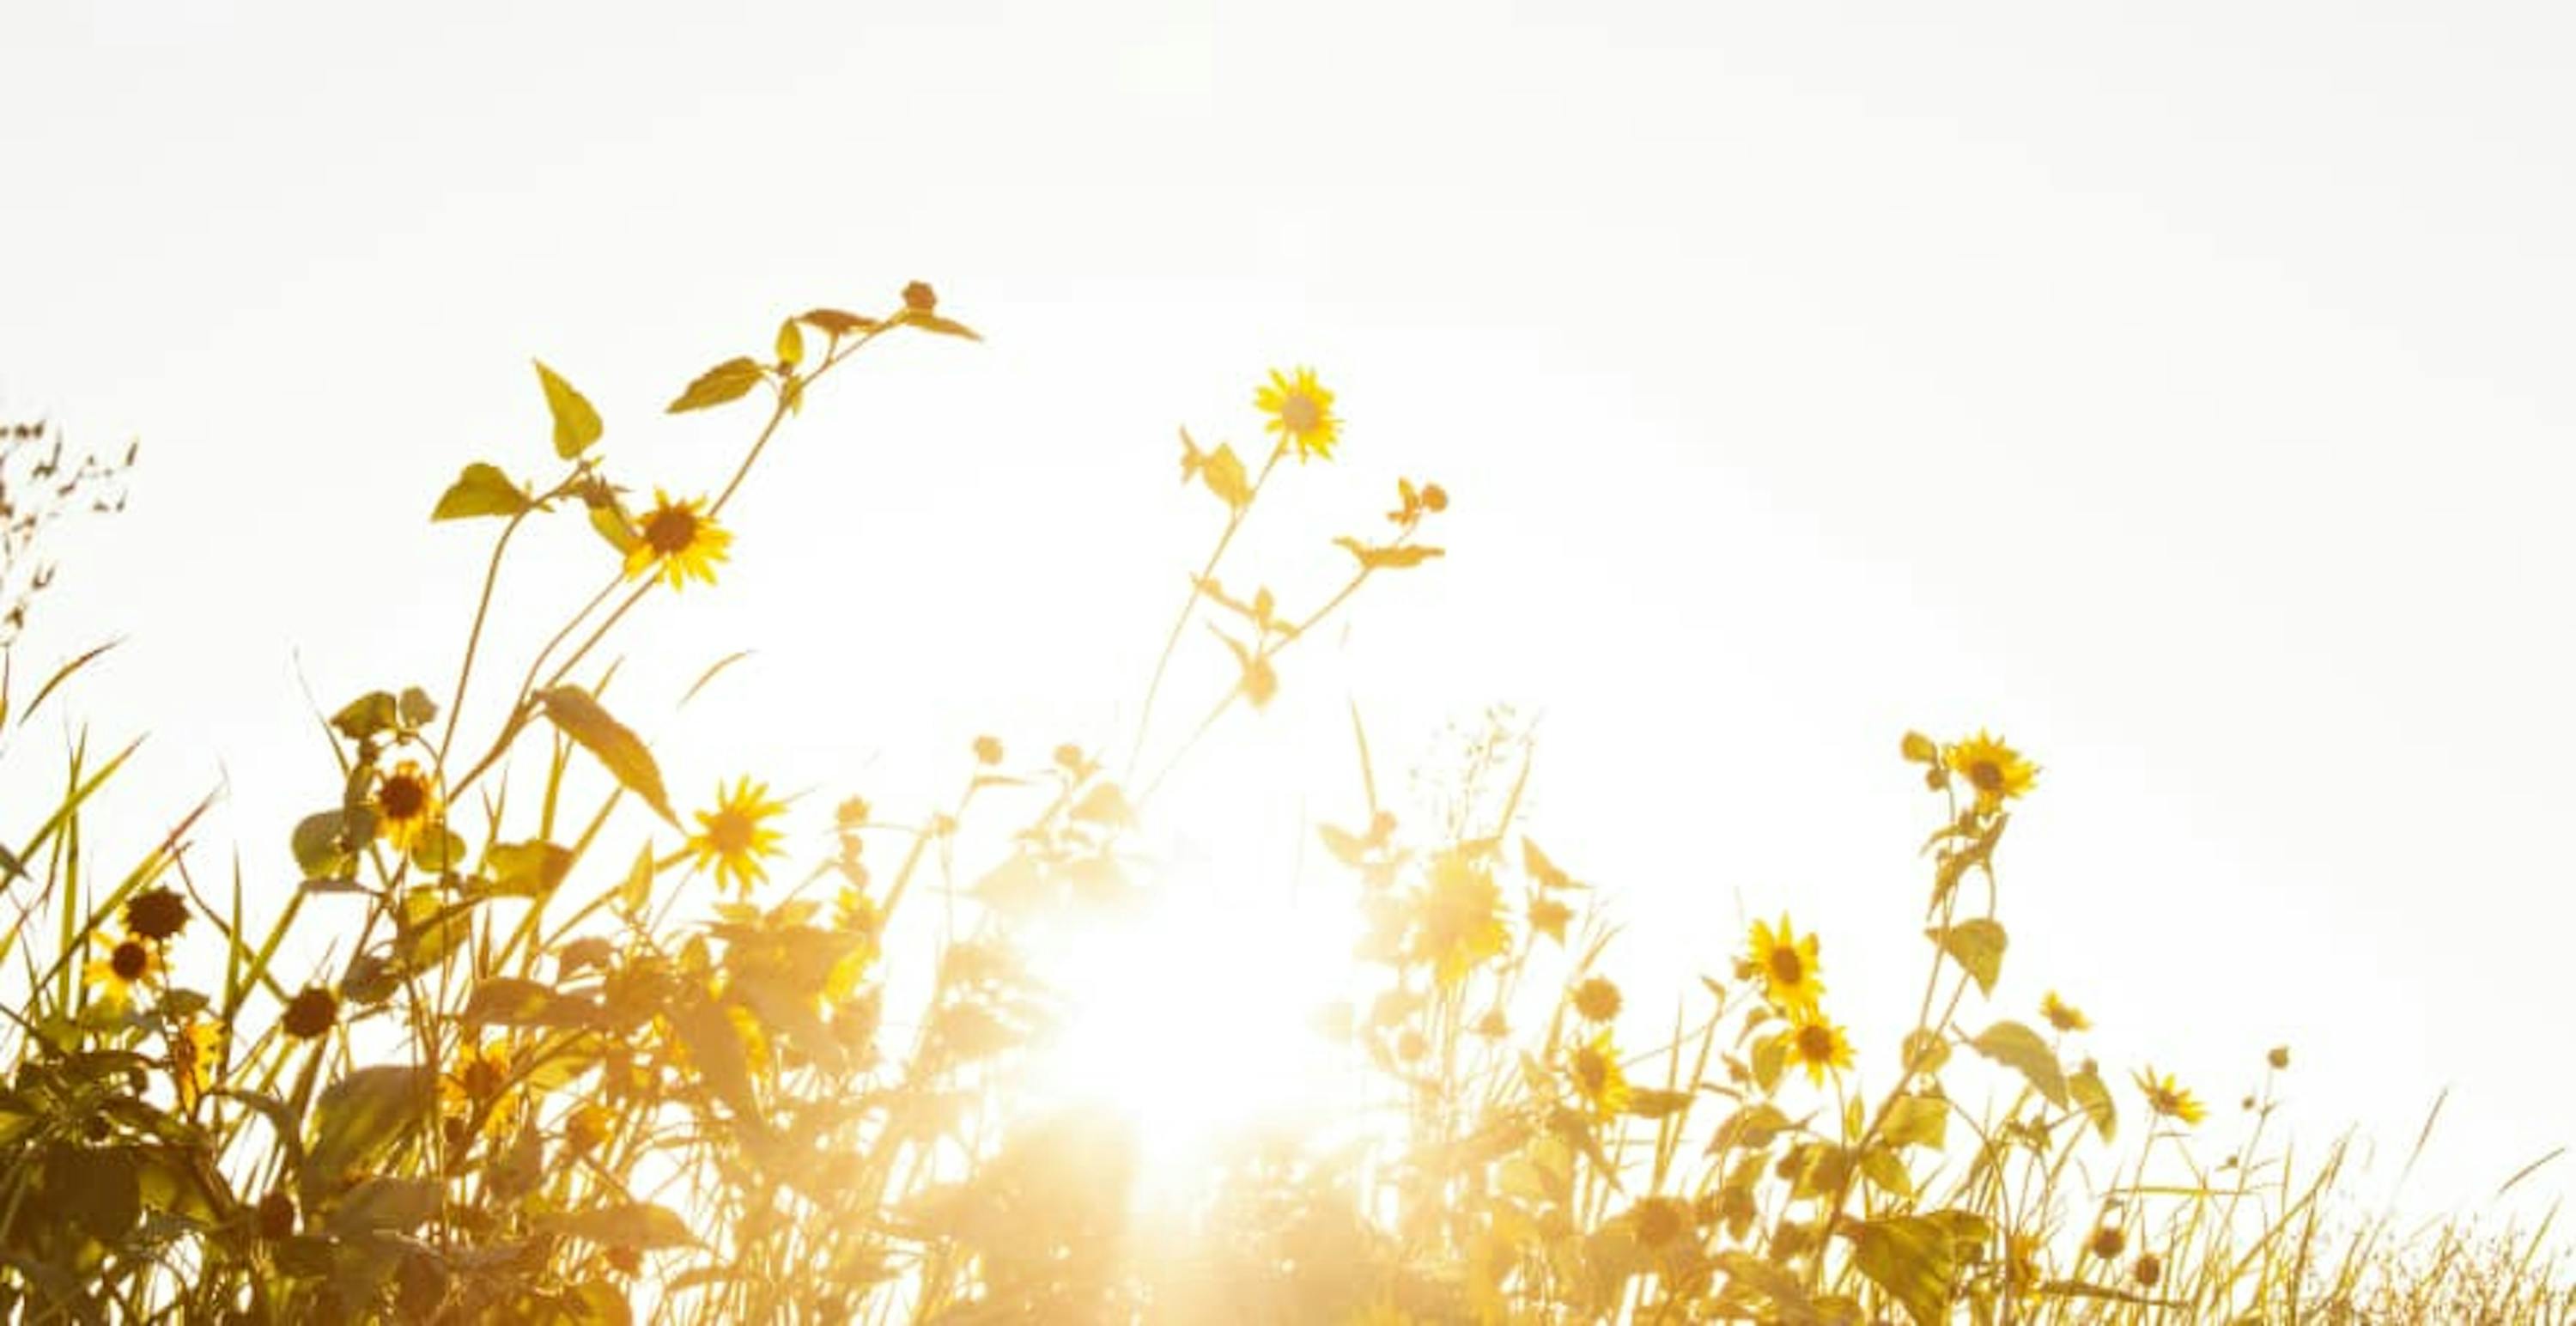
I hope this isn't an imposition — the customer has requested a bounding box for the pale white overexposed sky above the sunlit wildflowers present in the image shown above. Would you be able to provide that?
[0,0,2576,1231]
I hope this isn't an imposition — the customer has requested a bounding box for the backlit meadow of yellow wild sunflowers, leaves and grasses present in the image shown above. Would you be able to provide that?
[0,295,2576,1326]
